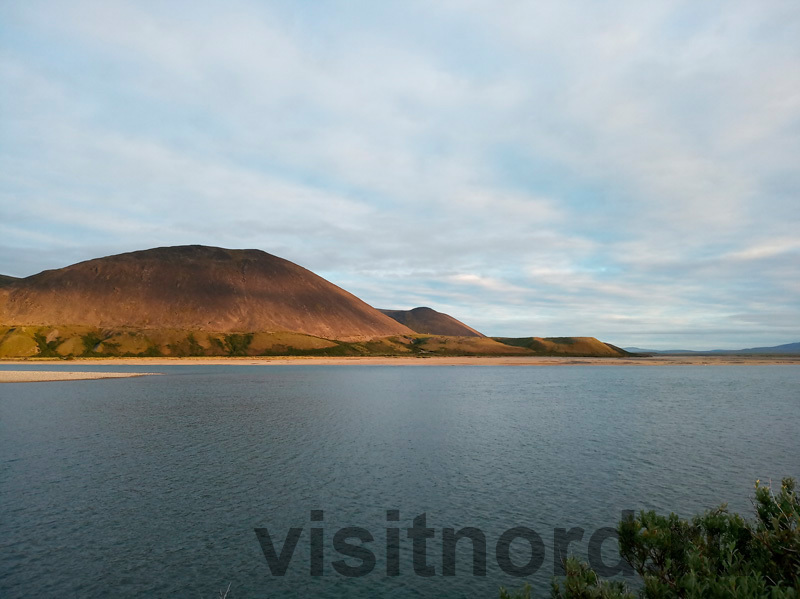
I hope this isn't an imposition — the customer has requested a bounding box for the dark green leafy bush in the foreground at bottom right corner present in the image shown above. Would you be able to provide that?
[500,478,800,599]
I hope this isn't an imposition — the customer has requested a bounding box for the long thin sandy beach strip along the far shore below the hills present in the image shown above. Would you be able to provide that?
[0,356,800,368]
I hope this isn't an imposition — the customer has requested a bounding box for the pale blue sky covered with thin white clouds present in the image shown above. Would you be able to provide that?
[0,0,800,349]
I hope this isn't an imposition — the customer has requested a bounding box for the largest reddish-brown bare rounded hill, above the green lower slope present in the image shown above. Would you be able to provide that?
[0,246,412,339]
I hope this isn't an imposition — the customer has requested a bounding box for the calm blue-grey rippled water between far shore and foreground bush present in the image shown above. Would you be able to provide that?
[0,364,800,599]
